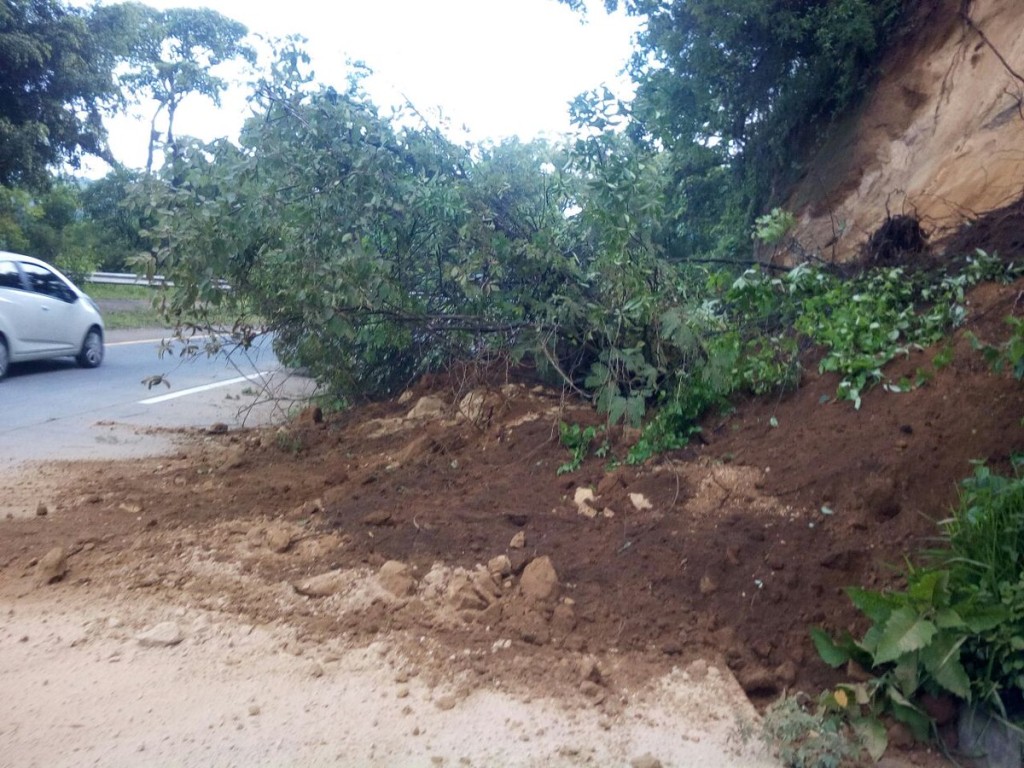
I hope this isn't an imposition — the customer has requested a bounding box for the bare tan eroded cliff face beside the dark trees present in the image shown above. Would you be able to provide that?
[788,0,1024,261]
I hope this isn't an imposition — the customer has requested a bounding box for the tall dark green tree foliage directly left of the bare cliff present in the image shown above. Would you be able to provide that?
[562,0,911,259]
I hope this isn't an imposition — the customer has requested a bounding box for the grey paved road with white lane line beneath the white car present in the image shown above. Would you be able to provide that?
[0,331,311,469]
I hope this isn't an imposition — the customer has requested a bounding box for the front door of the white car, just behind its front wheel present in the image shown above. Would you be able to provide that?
[18,261,82,354]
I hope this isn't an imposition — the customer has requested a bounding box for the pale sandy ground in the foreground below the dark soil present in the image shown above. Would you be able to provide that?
[0,584,773,768]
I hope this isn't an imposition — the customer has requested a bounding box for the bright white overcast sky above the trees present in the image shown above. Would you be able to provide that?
[94,0,636,167]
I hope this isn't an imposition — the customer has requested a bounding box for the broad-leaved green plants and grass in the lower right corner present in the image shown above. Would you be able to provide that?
[812,465,1024,739]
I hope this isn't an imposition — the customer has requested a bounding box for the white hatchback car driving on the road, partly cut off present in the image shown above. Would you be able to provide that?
[0,251,103,379]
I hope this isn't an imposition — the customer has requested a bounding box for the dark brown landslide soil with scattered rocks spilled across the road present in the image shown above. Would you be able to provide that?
[0,274,1024,765]
